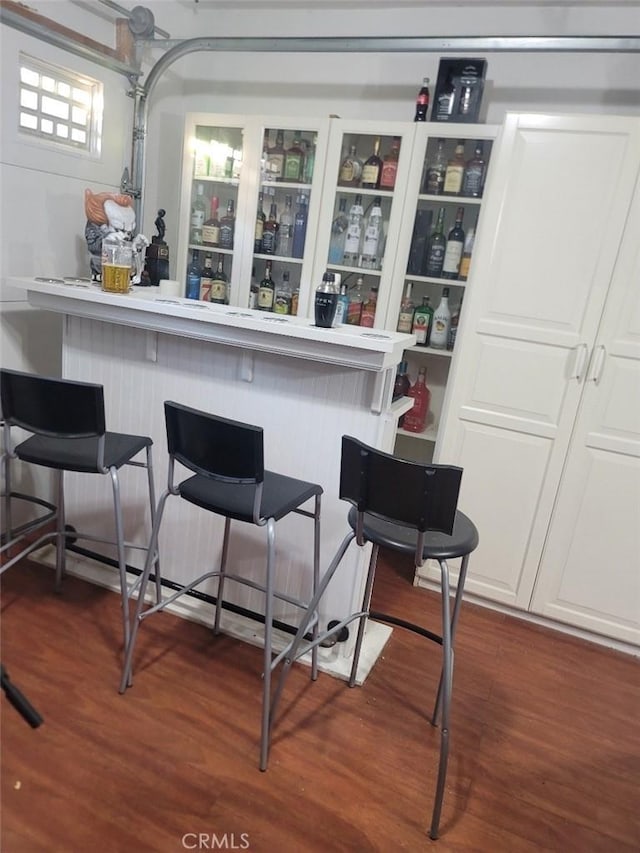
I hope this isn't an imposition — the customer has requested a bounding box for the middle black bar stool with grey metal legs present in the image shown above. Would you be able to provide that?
[120,401,322,770]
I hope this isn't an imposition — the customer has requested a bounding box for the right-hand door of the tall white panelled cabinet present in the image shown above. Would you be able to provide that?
[531,173,640,644]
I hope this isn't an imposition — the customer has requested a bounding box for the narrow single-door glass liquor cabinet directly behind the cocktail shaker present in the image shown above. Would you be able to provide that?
[314,119,414,328]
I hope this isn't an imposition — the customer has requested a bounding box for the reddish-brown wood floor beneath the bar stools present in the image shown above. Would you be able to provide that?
[1,559,640,853]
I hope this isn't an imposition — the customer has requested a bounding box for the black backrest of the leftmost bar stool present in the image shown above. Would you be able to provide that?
[0,368,106,438]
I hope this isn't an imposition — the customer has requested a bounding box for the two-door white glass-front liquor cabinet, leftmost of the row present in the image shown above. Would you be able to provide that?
[177,114,329,314]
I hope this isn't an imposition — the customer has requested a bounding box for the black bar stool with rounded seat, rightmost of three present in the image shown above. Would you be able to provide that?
[271,436,478,839]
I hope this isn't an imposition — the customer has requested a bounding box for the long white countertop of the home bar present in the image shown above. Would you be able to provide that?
[6,278,415,372]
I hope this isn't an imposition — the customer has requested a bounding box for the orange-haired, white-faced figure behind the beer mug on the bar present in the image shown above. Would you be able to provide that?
[84,190,149,284]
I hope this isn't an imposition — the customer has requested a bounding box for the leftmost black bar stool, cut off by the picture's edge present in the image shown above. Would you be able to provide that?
[0,368,160,648]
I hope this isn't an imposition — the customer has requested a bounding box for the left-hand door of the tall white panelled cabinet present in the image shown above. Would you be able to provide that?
[435,115,640,608]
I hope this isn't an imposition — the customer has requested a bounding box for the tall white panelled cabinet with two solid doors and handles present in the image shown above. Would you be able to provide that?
[436,115,640,642]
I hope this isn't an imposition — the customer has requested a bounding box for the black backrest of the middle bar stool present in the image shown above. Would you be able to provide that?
[164,400,264,484]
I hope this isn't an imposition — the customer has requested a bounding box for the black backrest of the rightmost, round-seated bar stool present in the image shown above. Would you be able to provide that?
[340,435,462,541]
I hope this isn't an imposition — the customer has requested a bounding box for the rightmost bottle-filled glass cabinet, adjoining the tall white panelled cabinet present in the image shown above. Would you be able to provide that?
[385,123,497,461]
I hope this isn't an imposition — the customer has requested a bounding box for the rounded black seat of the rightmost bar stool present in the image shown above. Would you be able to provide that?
[348,507,479,560]
